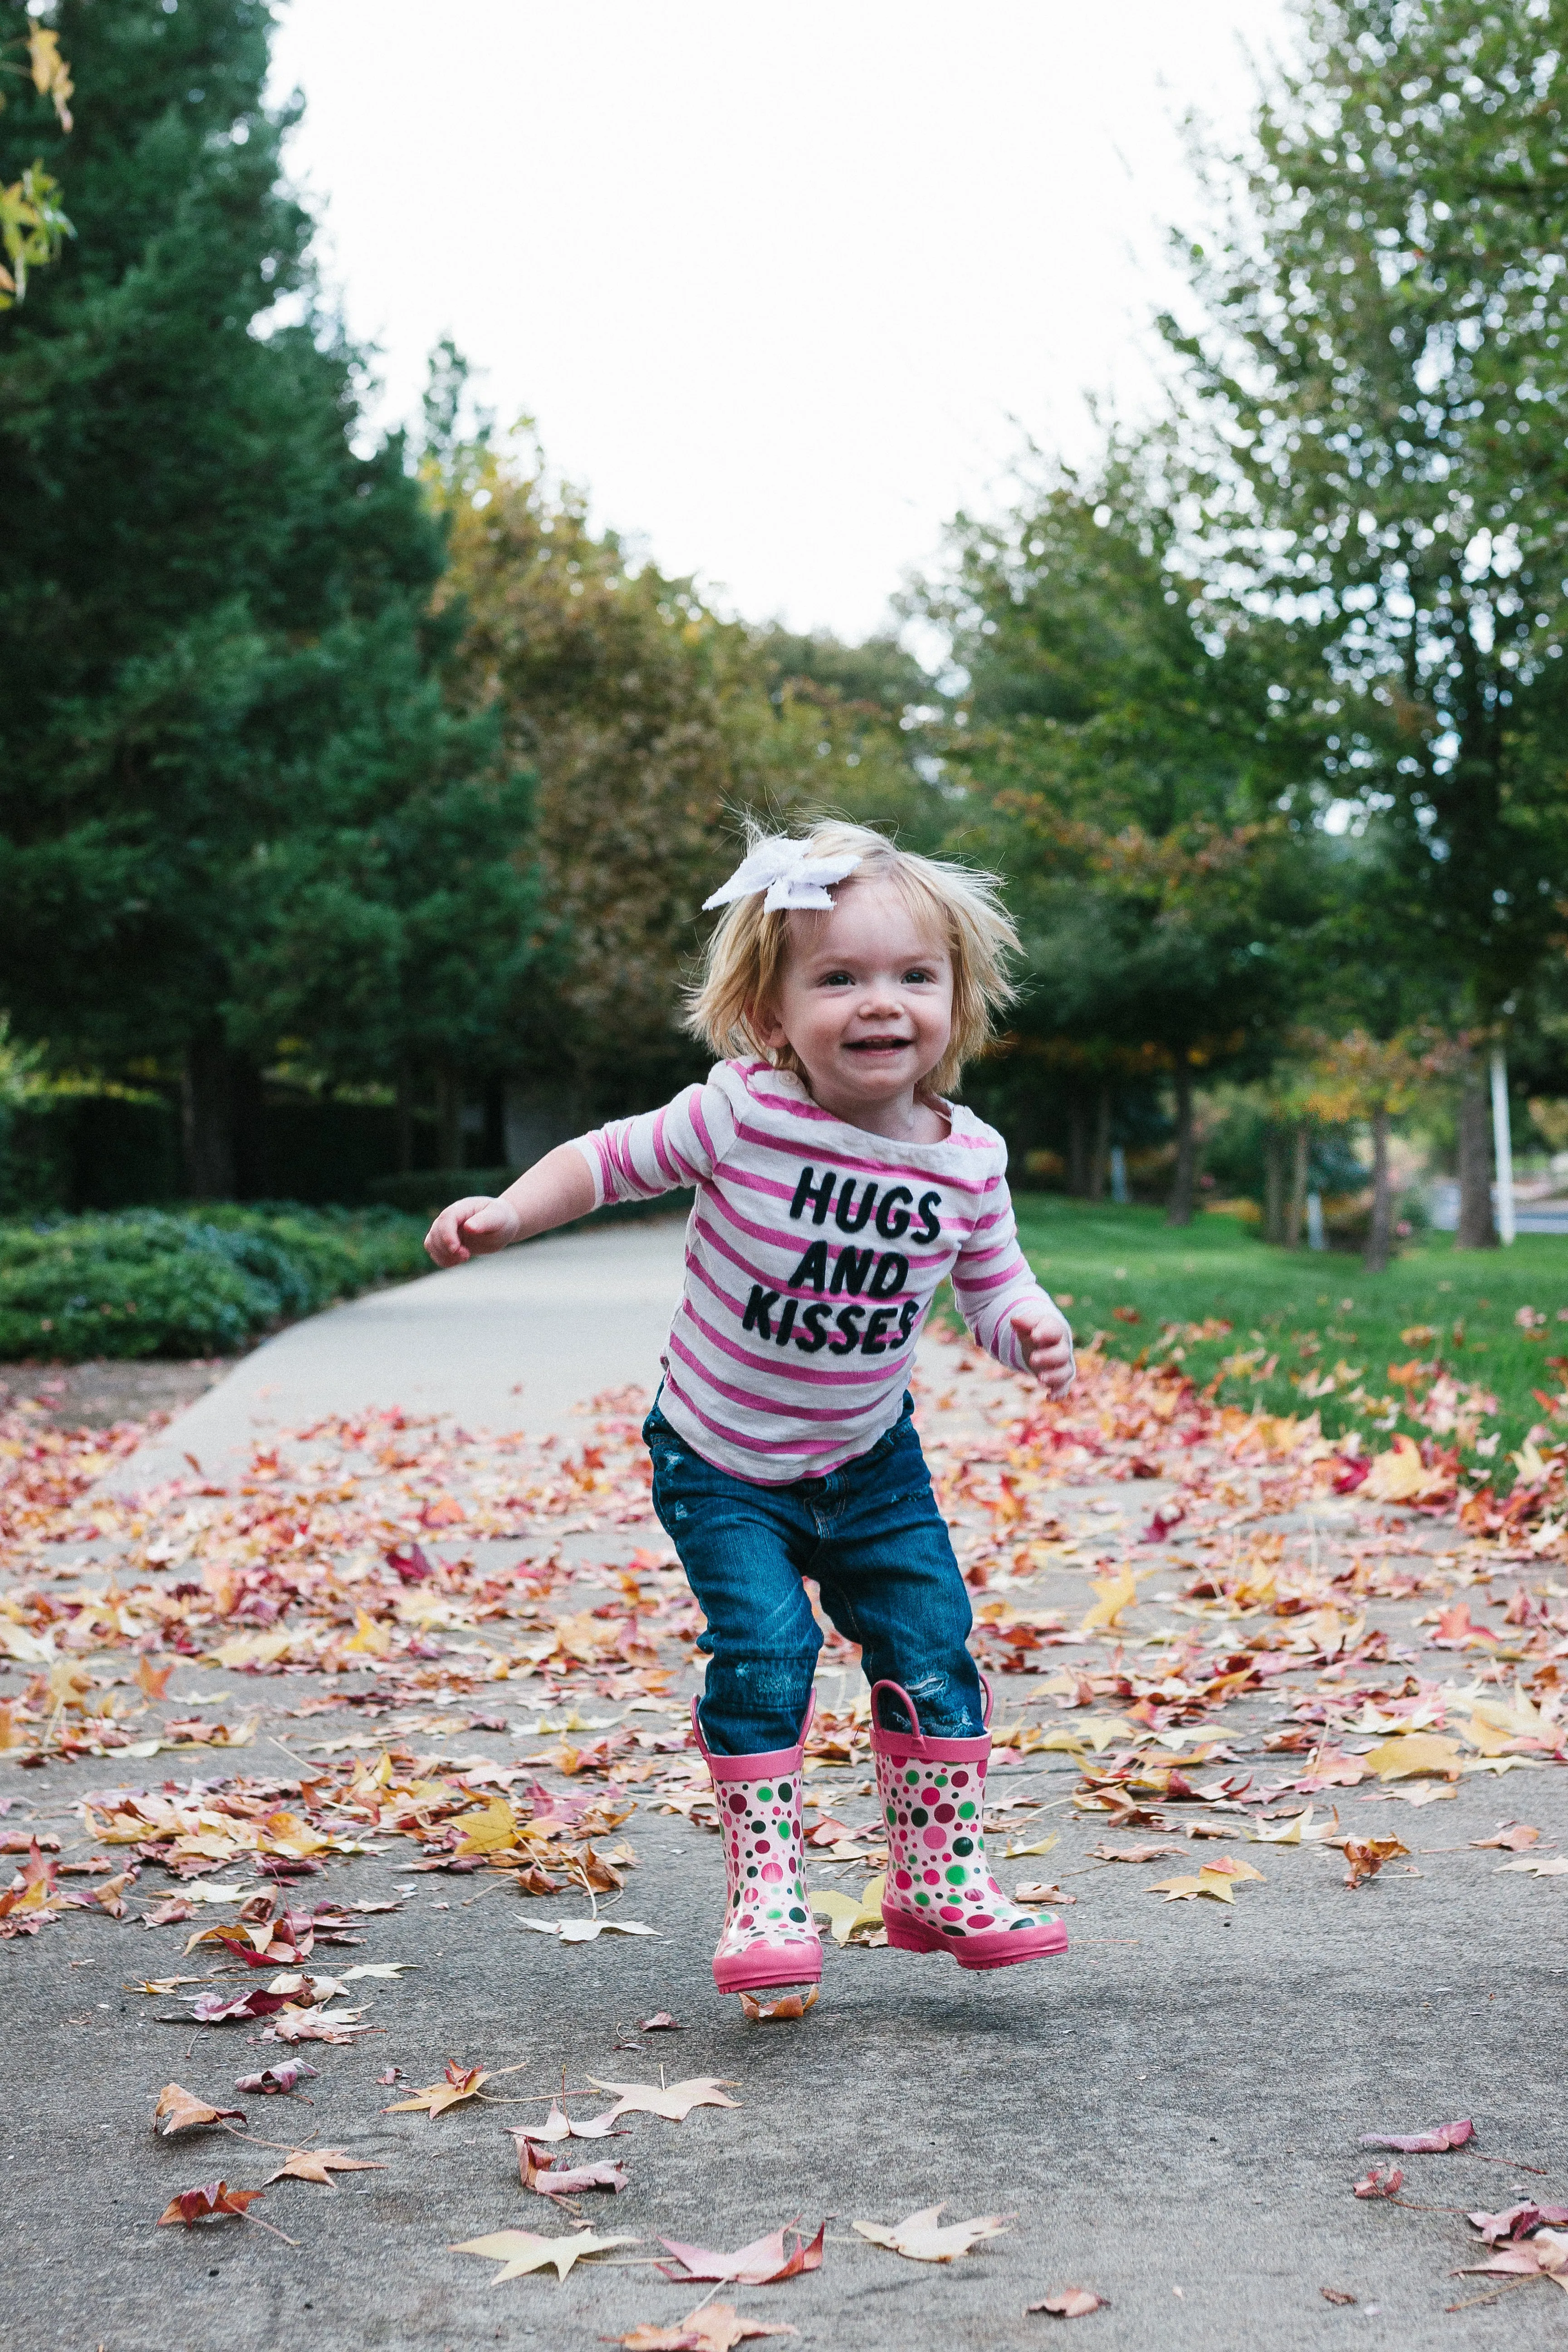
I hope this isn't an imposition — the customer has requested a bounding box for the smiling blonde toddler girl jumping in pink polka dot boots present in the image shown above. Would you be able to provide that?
[426,823,1072,1992]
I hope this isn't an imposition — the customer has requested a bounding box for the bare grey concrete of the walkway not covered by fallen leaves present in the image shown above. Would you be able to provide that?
[0,1223,1568,2352]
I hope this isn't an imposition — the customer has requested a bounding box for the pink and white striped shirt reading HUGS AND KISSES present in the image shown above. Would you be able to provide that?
[576,1061,1062,1486]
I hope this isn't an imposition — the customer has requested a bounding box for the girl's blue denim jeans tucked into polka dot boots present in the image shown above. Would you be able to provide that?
[642,1397,985,1757]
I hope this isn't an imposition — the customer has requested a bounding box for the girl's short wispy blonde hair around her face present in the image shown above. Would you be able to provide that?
[686,818,1018,1094]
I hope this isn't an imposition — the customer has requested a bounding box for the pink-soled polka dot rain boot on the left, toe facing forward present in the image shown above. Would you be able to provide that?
[691,1700,823,1992]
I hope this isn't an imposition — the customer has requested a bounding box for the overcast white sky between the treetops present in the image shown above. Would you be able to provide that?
[275,0,1291,635]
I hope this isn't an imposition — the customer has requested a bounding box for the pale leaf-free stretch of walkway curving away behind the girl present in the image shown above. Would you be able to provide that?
[111,1216,686,1491]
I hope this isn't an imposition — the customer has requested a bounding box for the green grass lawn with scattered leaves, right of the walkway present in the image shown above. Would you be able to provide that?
[1013,1192,1568,1484]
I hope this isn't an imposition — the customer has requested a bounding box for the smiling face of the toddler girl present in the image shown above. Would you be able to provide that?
[757,880,952,1110]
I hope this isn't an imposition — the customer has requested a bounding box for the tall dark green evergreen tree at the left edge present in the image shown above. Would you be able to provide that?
[0,0,534,1195]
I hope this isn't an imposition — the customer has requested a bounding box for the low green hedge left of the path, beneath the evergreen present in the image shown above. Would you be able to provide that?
[0,1206,430,1364]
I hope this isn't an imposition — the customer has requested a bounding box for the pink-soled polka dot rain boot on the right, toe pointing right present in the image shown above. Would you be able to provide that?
[872,1682,1067,1969]
